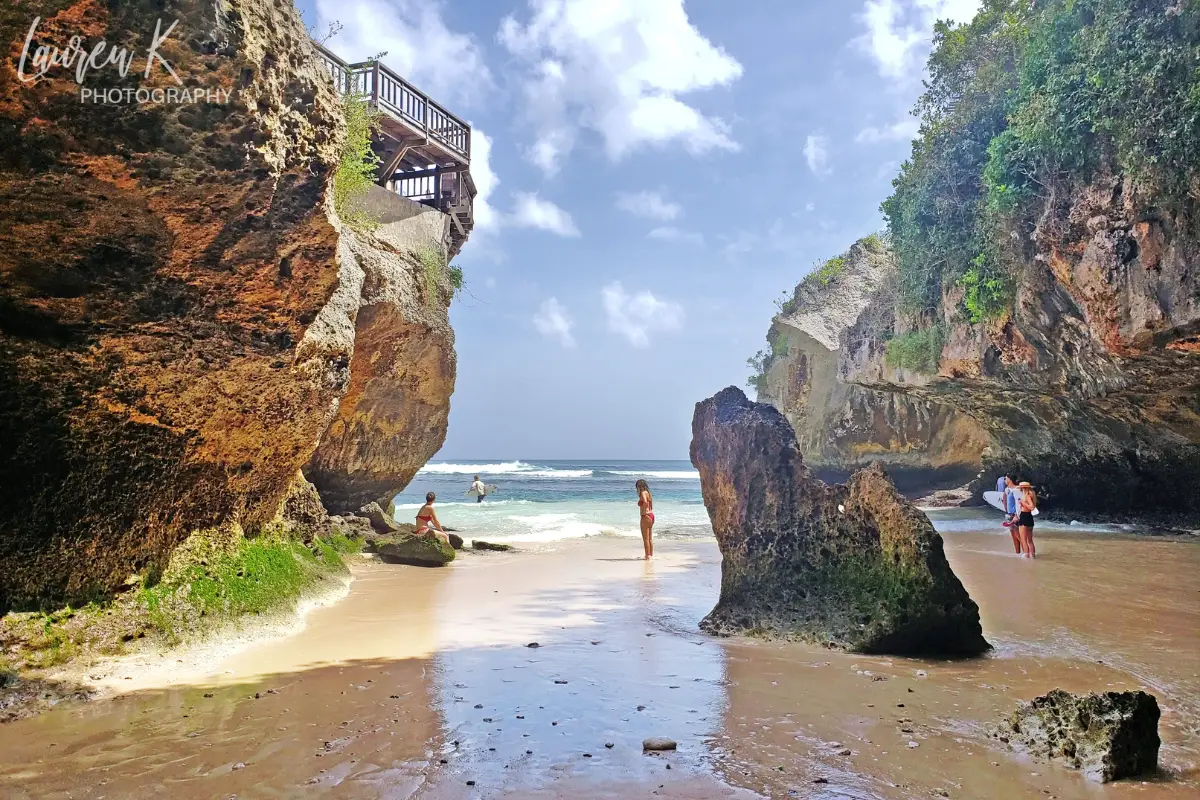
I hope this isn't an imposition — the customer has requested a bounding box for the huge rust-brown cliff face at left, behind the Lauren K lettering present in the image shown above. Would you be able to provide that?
[0,0,454,609]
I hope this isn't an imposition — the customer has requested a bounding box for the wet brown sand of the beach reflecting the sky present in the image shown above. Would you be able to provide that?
[0,531,1200,800]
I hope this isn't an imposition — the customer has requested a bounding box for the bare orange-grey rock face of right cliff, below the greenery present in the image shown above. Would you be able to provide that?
[839,176,1200,515]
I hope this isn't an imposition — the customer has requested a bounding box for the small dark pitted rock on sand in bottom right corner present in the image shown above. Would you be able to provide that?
[994,688,1160,783]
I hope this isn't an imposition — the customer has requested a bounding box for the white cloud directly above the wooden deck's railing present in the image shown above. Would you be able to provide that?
[316,0,492,110]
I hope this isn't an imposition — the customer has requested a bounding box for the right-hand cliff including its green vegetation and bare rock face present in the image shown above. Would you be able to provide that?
[859,0,1200,519]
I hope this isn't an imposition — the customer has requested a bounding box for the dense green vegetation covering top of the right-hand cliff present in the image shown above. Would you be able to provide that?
[882,0,1200,323]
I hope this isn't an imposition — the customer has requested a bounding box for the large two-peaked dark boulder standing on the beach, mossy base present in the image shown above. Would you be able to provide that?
[691,386,989,656]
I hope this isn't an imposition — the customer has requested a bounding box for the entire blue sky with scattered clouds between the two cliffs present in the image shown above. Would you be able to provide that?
[296,0,978,459]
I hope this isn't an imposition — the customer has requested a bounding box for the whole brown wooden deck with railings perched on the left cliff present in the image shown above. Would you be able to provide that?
[313,42,475,257]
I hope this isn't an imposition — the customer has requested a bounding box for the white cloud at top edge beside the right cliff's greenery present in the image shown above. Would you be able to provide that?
[856,0,980,80]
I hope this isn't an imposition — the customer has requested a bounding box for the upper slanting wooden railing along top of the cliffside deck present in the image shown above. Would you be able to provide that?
[313,42,470,163]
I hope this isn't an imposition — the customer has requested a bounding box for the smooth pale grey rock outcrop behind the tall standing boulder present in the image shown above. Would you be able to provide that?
[756,236,991,491]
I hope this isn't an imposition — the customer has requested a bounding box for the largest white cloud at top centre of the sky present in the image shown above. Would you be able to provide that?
[498,0,742,174]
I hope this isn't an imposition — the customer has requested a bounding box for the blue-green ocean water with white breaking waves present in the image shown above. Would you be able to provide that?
[386,459,1133,542]
